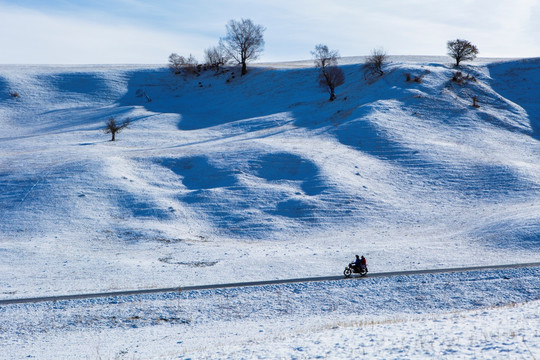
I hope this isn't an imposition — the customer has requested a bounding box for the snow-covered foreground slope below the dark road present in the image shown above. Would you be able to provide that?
[0,268,540,359]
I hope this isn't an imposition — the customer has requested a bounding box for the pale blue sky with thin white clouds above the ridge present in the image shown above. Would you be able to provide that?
[0,0,540,64]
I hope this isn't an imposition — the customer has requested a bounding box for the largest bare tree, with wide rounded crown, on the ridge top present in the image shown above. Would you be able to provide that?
[222,19,266,75]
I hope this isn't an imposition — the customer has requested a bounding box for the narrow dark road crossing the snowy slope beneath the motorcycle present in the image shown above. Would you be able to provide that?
[0,262,540,306]
